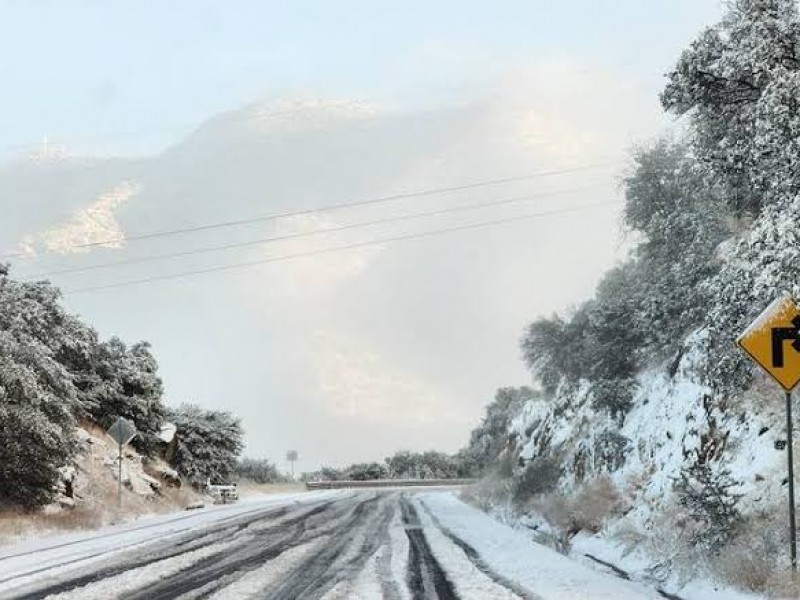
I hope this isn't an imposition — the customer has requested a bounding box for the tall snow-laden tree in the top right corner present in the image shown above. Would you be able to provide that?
[662,0,800,215]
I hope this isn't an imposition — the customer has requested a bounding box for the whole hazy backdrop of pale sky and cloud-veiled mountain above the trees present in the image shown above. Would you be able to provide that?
[0,0,719,468]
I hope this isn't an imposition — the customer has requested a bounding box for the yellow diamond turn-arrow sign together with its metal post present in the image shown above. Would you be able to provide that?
[736,296,800,573]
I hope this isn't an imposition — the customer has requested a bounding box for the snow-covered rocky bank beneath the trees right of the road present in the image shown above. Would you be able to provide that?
[510,335,786,527]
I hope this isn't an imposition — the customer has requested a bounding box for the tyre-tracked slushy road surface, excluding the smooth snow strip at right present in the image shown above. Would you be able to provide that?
[0,491,534,600]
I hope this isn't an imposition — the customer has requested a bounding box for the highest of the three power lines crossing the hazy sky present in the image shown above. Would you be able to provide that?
[0,161,620,258]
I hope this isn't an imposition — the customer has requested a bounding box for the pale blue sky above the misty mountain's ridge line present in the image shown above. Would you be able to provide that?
[0,0,719,155]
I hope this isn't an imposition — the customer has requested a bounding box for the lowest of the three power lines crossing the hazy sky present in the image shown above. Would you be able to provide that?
[64,200,622,294]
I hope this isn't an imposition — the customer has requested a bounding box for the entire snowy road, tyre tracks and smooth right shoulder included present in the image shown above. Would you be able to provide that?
[0,490,659,600]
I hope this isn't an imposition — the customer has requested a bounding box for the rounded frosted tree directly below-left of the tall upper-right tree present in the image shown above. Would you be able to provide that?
[624,139,730,358]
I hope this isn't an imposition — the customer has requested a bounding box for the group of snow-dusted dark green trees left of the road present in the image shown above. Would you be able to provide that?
[0,265,248,510]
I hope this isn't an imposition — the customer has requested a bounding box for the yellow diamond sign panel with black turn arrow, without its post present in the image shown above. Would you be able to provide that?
[736,296,800,392]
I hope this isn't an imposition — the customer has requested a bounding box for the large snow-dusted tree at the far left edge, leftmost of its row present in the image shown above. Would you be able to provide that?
[0,267,76,508]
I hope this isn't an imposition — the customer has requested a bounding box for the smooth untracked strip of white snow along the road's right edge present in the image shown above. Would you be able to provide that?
[418,493,661,600]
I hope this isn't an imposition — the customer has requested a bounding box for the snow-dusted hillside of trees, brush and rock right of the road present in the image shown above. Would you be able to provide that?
[456,0,800,597]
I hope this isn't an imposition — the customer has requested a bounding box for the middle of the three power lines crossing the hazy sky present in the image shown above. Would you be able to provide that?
[27,186,595,279]
